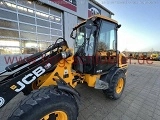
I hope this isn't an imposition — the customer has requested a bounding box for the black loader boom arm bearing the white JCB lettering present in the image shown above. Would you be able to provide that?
[0,41,71,108]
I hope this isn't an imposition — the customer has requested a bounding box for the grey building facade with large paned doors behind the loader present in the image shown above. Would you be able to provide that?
[0,0,113,71]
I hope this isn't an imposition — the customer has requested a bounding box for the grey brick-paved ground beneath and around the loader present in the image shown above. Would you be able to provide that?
[0,61,160,120]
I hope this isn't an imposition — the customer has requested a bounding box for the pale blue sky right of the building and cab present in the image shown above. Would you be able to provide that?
[97,0,160,52]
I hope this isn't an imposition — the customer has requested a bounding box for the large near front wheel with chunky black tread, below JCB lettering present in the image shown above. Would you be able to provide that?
[8,86,78,120]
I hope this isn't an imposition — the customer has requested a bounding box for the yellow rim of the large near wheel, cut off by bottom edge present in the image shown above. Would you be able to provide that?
[41,111,68,120]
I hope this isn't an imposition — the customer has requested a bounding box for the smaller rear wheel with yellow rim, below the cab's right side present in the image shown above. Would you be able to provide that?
[103,71,126,100]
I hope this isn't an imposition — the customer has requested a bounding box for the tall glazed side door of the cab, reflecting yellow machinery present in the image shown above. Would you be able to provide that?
[95,21,118,73]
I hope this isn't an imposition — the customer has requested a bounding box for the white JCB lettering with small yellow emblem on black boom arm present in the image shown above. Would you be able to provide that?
[10,66,46,92]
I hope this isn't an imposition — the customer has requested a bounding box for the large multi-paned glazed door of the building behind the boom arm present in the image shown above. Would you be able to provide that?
[0,0,63,54]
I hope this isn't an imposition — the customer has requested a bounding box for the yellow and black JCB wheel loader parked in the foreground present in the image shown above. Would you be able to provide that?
[0,15,127,120]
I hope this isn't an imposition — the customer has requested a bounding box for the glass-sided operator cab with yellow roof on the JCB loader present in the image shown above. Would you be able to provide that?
[71,15,120,74]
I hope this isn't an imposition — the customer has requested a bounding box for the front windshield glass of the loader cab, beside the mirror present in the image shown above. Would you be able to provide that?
[75,24,96,56]
